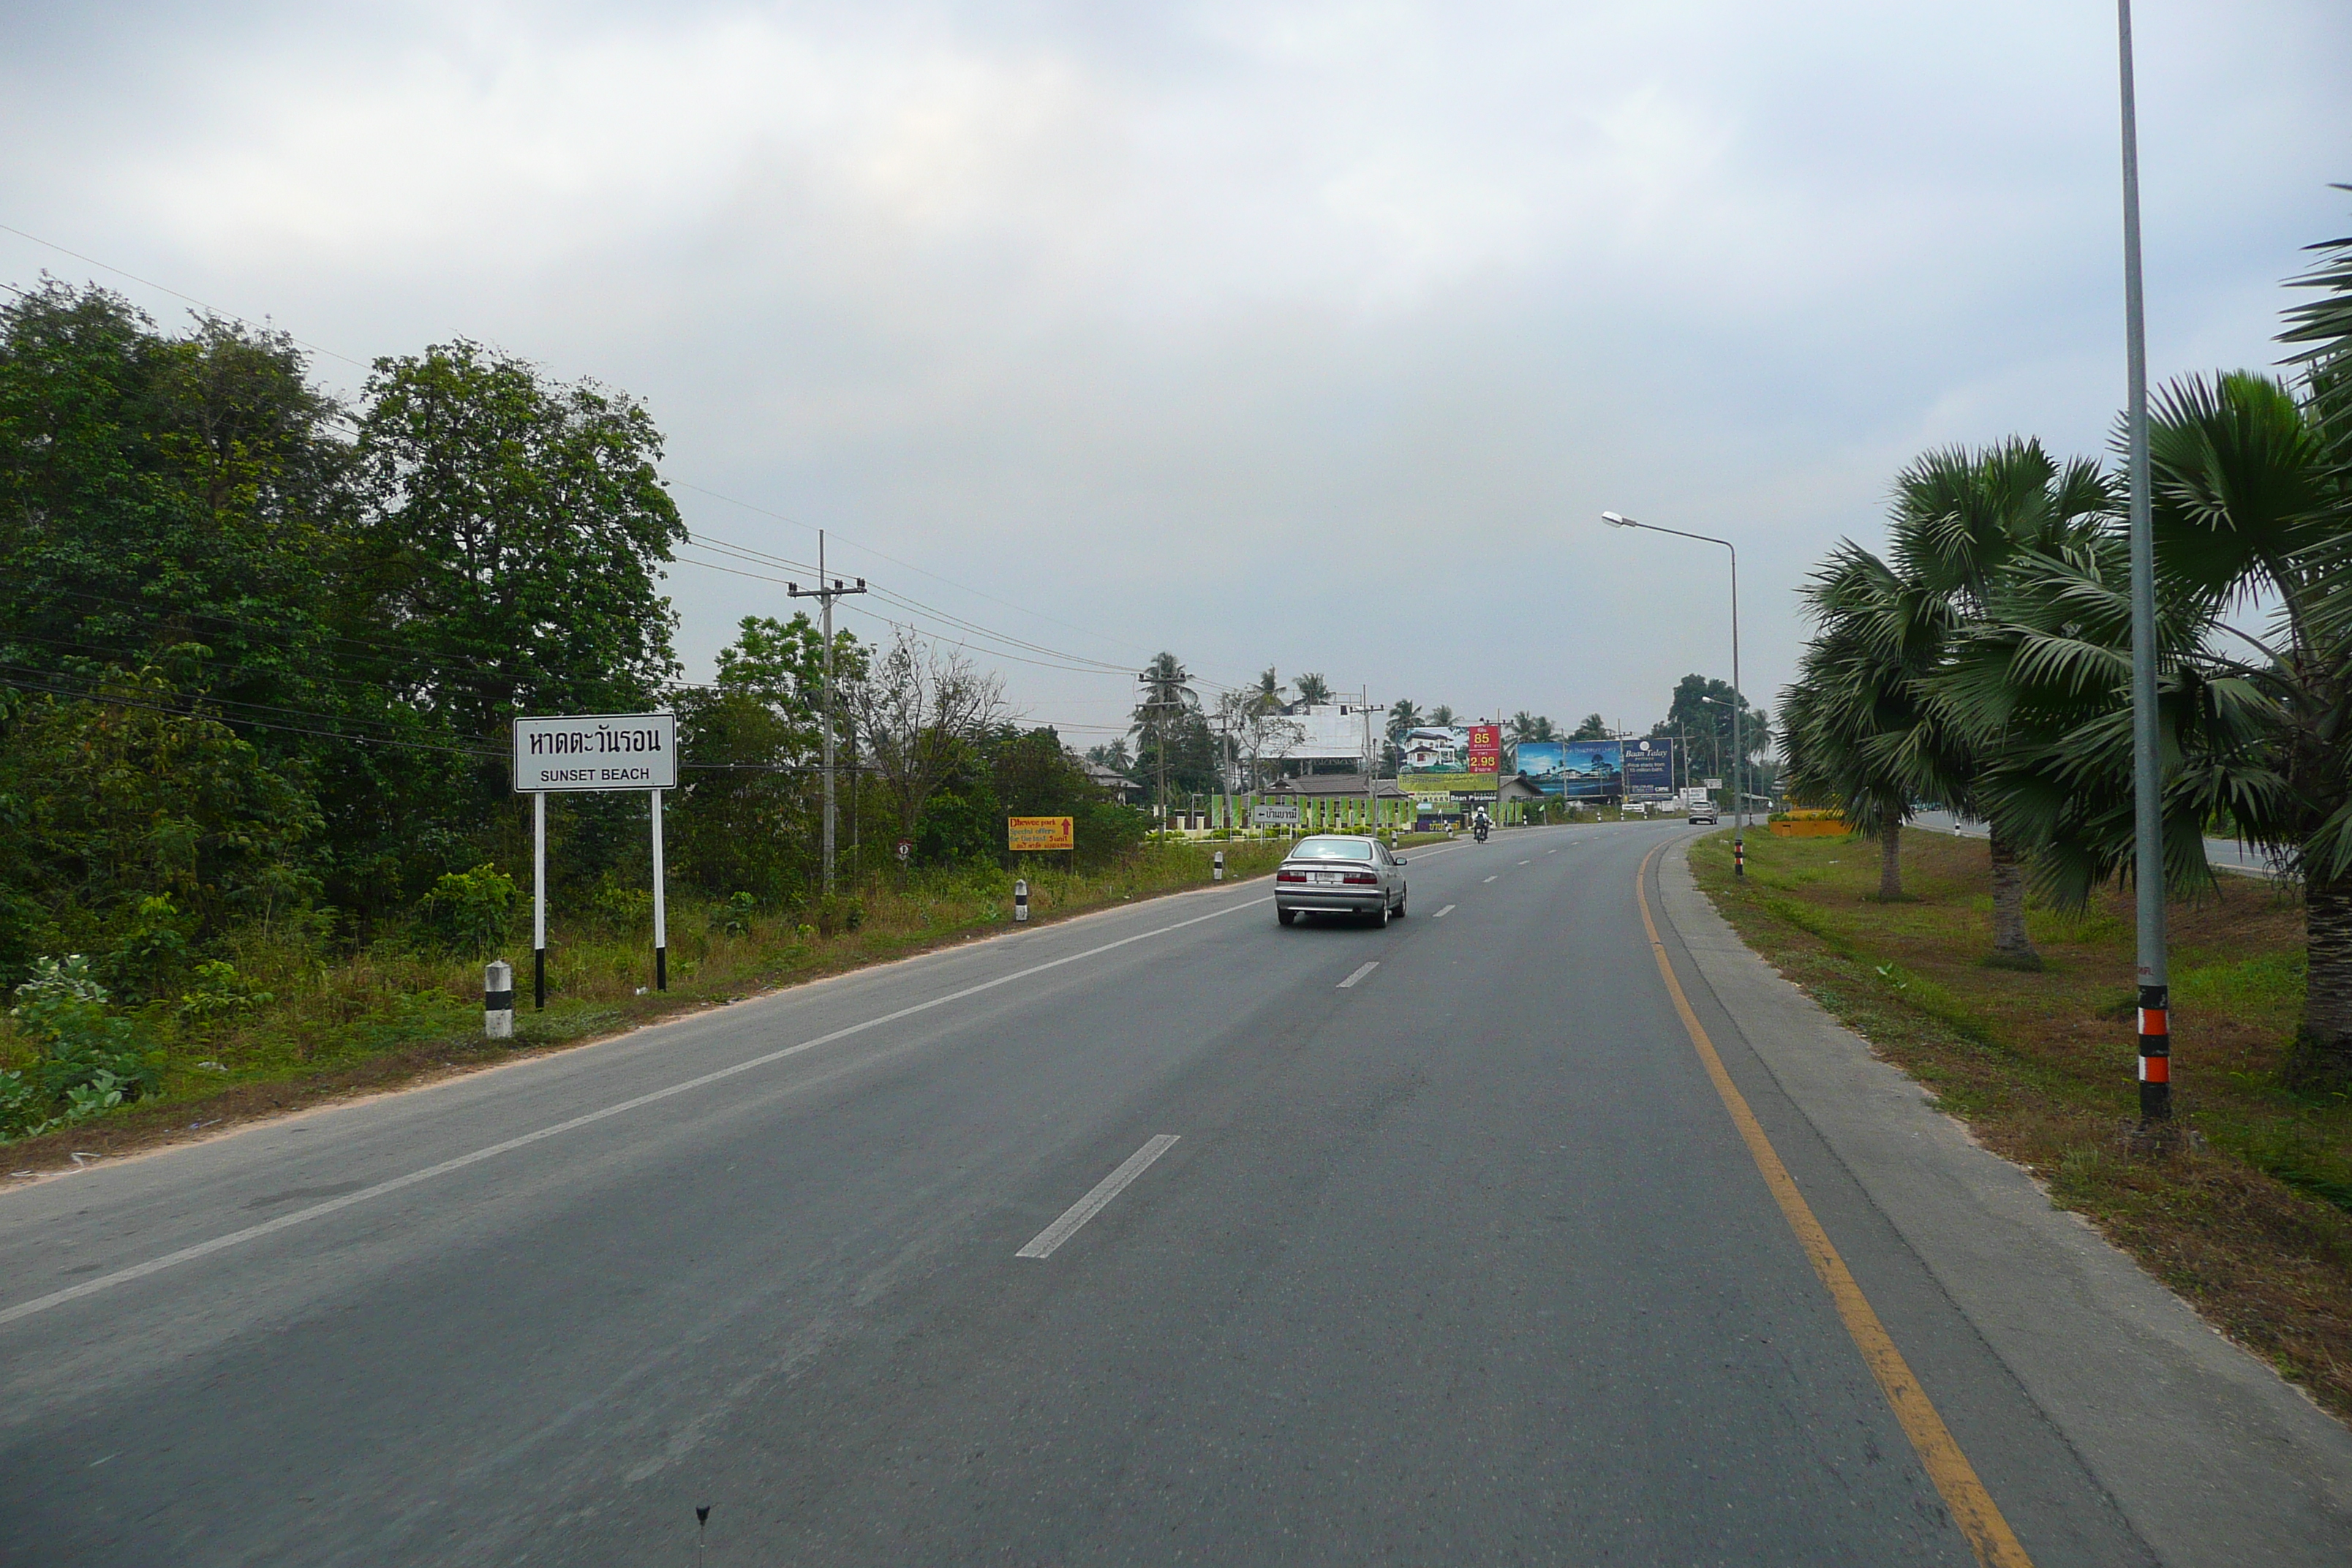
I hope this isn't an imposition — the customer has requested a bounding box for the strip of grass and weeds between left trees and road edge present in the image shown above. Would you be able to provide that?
[0,840,1286,1169]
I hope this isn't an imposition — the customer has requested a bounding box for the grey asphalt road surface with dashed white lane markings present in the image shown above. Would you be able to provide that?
[0,823,2258,1566]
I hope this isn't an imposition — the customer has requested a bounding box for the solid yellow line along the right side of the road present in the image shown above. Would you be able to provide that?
[1632,846,2032,1568]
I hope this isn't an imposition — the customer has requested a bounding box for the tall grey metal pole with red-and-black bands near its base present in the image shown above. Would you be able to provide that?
[2114,0,2174,1121]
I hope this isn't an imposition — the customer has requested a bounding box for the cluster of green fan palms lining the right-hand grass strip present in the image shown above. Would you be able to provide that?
[1781,206,2352,1093]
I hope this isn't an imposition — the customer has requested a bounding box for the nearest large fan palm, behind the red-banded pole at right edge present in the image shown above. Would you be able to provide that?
[1957,364,2352,1086]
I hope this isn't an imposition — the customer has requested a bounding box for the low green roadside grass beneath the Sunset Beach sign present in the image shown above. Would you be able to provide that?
[0,840,1430,1175]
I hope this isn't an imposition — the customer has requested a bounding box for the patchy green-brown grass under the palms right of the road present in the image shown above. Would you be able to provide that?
[1691,830,2352,1417]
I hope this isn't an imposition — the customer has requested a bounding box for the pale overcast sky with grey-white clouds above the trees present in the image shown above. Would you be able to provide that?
[0,0,2352,745]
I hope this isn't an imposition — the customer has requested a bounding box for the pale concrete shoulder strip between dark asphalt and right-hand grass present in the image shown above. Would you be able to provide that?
[1658,844,2352,1568]
